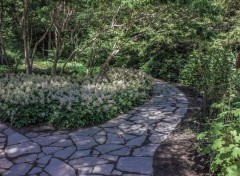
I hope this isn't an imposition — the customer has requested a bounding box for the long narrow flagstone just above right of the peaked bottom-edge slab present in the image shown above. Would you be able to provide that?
[69,157,109,168]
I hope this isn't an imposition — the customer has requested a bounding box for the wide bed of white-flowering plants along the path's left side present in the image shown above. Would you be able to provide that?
[0,68,152,129]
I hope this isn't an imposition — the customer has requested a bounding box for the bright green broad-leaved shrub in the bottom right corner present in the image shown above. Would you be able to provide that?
[198,95,240,176]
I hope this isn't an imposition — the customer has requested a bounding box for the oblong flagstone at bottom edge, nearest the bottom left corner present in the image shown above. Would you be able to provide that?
[3,163,32,176]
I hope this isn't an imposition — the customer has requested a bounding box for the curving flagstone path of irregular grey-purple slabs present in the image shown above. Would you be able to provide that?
[0,82,188,176]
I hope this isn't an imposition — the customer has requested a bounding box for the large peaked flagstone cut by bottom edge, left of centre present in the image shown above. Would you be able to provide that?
[44,158,76,176]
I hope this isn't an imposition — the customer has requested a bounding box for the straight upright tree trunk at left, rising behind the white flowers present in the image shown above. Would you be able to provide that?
[22,0,32,75]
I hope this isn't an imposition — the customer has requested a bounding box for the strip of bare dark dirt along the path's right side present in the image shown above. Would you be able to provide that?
[153,84,210,176]
